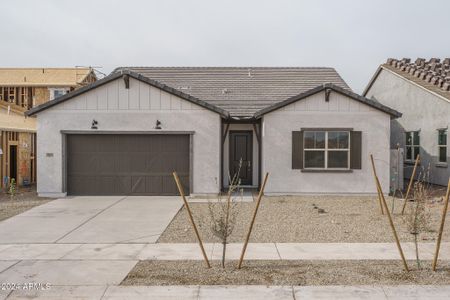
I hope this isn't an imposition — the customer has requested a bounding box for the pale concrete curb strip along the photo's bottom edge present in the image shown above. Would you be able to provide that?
[5,285,450,300]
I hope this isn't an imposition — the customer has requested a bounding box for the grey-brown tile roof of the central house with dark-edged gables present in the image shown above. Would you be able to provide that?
[25,68,401,119]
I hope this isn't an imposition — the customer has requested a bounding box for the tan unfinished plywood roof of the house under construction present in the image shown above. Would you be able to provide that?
[0,68,95,87]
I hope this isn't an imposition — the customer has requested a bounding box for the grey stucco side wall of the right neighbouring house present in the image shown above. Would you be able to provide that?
[365,69,450,185]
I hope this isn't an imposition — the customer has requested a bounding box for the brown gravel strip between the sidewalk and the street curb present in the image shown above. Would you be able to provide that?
[121,260,450,285]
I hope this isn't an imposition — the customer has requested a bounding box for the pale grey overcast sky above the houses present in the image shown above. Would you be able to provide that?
[0,0,450,92]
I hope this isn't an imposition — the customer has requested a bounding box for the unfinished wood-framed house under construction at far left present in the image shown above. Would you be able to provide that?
[0,68,96,188]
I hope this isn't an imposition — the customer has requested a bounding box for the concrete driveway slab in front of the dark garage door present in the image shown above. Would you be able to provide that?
[0,196,182,244]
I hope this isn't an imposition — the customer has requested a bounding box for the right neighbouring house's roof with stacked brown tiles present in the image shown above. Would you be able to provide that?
[363,58,450,100]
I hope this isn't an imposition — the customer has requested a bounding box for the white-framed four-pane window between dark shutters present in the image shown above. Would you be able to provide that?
[303,131,350,170]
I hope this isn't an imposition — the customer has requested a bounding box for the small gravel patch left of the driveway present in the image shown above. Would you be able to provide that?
[0,187,51,221]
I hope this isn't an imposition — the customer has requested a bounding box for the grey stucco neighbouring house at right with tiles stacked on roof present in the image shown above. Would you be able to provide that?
[363,58,450,186]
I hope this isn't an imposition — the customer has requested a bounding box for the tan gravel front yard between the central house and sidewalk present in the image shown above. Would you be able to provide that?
[158,196,450,243]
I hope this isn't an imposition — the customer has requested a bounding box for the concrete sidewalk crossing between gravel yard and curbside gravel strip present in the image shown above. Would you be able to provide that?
[0,242,444,260]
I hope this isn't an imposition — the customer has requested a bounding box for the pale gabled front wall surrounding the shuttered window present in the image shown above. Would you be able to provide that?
[262,91,390,194]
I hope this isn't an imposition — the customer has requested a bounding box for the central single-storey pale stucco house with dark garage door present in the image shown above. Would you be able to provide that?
[27,67,401,197]
